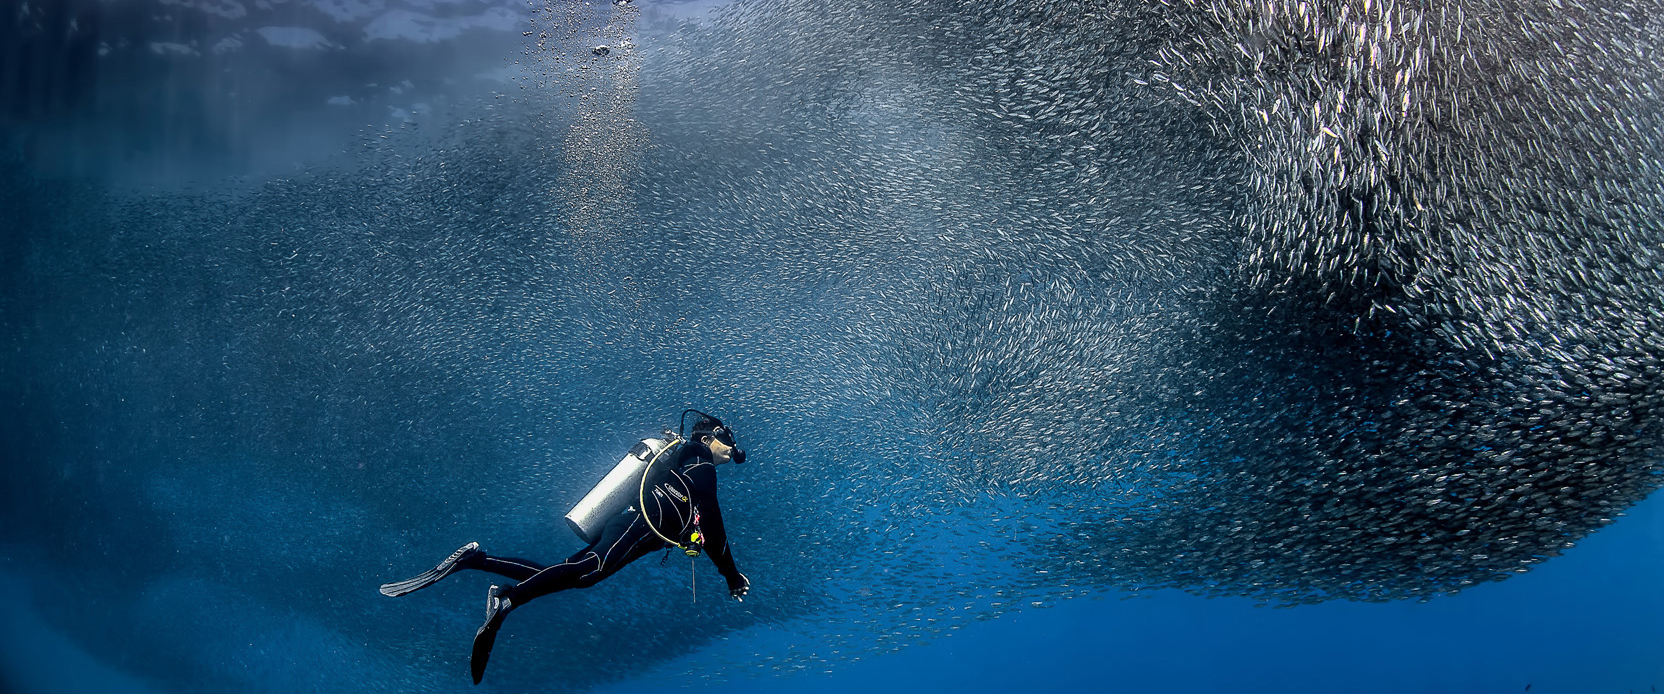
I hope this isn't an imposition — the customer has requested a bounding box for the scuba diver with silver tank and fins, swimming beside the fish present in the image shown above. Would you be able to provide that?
[381,409,750,684]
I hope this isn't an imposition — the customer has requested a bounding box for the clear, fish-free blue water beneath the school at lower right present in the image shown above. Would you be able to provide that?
[601,499,1664,694]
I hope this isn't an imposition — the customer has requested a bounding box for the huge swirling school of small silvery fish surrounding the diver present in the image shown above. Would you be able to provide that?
[0,0,1664,691]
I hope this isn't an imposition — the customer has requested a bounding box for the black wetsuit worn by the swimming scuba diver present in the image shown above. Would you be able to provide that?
[459,444,745,606]
